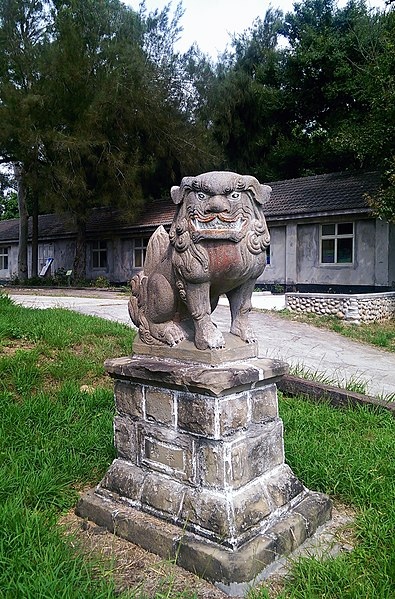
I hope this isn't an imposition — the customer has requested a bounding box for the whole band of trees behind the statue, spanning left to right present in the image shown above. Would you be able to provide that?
[0,0,395,276]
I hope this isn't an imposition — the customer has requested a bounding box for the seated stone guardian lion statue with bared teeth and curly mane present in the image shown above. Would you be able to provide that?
[129,171,271,349]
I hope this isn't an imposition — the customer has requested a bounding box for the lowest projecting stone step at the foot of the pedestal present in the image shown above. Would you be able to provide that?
[76,490,332,596]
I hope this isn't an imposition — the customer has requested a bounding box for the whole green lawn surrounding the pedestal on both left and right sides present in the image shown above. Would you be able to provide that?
[0,296,395,599]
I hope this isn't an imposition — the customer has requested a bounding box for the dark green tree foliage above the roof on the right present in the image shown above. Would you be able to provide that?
[200,0,395,192]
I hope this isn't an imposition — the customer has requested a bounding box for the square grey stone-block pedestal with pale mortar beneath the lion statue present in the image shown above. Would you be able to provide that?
[77,344,331,595]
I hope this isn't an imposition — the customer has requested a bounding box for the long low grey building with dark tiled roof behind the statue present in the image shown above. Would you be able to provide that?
[0,172,395,293]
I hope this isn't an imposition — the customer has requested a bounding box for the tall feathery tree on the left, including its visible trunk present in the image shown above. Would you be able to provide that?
[0,0,223,278]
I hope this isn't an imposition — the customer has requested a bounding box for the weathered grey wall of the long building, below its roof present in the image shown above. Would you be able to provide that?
[0,219,395,286]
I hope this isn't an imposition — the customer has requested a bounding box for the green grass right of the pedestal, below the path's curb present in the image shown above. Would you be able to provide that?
[254,398,395,599]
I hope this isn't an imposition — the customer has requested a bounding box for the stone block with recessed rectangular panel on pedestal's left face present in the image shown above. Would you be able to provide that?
[137,422,195,482]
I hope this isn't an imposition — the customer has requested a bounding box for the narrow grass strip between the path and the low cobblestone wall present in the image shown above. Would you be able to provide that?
[277,310,395,352]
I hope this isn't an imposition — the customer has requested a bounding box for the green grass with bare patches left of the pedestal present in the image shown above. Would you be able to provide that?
[0,296,133,599]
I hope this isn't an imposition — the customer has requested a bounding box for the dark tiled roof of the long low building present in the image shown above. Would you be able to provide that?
[0,172,380,243]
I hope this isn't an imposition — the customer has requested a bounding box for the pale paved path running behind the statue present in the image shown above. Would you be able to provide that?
[11,294,395,397]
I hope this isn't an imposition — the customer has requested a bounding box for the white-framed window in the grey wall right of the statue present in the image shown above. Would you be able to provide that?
[321,223,354,264]
